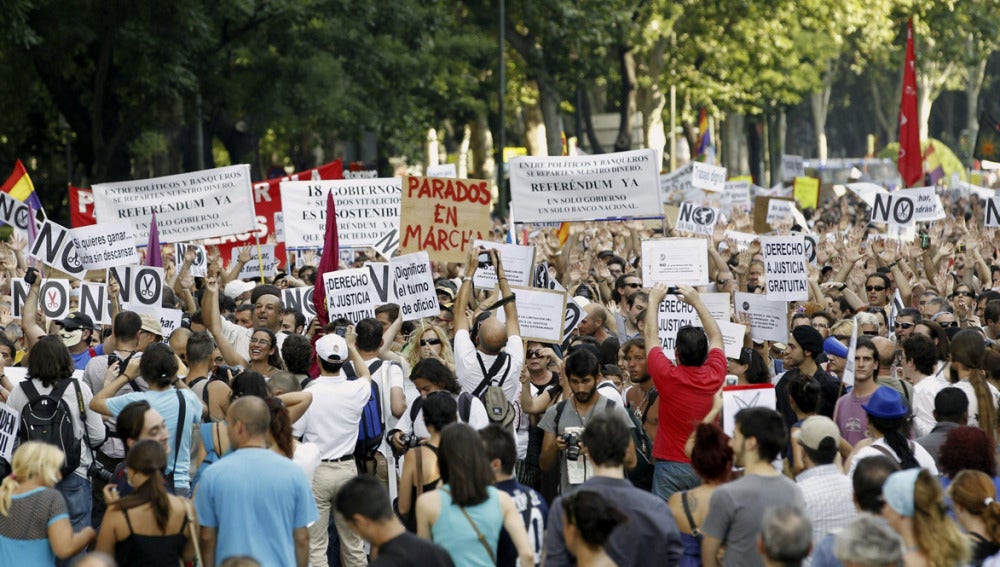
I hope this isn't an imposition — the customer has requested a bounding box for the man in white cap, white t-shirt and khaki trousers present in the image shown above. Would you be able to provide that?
[293,328,371,567]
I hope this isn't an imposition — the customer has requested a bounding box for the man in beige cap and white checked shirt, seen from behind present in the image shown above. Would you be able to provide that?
[795,415,856,564]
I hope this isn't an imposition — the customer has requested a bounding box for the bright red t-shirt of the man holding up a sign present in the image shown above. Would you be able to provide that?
[647,348,727,463]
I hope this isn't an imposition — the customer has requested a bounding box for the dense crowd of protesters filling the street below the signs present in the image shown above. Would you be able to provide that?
[0,184,1000,567]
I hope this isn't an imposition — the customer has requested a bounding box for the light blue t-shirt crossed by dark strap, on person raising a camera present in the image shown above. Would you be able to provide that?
[108,388,202,489]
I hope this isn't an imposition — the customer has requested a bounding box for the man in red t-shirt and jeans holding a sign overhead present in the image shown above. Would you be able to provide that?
[644,283,726,500]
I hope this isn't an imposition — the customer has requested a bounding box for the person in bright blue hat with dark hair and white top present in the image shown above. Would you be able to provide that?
[847,386,938,477]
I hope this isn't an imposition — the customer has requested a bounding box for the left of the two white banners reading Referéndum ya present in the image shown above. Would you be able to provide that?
[93,164,255,245]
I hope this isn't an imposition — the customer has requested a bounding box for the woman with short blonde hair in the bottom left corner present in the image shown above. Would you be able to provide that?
[0,441,94,566]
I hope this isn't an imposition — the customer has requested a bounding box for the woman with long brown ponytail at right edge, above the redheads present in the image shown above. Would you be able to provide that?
[950,329,1000,444]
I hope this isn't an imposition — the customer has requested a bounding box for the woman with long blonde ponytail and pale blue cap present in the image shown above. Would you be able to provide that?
[882,468,969,567]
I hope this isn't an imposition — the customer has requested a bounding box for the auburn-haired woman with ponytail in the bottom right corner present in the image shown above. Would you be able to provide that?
[948,471,1000,567]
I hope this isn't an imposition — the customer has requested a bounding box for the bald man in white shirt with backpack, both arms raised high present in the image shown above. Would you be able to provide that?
[455,248,524,404]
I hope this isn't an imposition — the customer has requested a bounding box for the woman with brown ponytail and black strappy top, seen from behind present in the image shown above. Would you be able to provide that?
[97,441,198,567]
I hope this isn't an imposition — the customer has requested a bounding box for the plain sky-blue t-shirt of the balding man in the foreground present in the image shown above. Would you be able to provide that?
[194,448,319,565]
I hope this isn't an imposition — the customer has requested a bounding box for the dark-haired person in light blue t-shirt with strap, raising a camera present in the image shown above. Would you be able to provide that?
[90,343,204,496]
